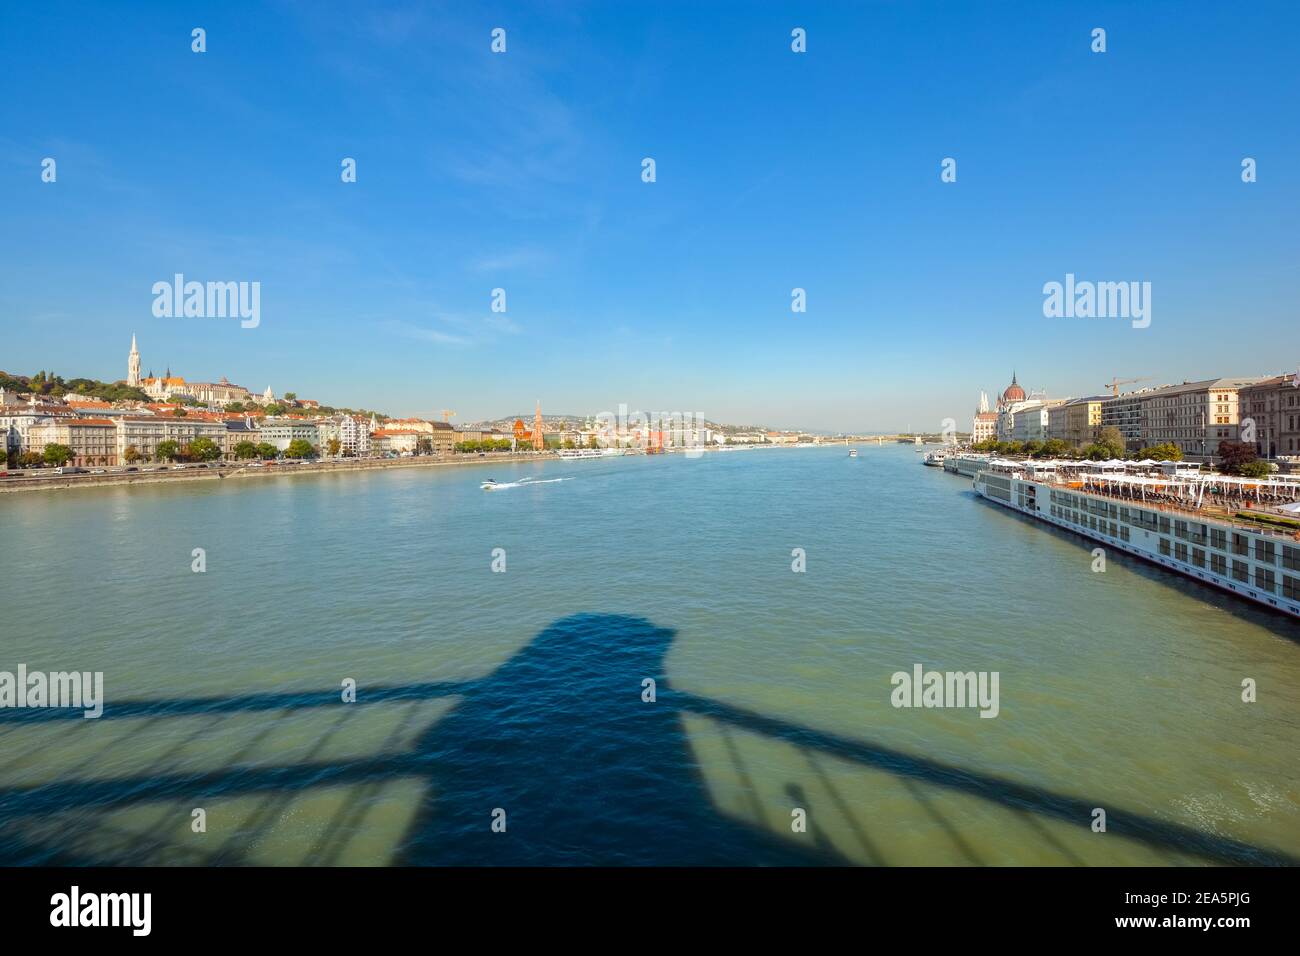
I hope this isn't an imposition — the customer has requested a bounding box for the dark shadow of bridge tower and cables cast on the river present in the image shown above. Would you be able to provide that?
[0,614,1297,865]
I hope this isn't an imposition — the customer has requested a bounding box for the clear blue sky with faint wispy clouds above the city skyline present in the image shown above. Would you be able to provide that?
[0,0,1300,429]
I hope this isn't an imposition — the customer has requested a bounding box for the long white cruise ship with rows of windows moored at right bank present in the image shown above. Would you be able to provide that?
[974,460,1300,619]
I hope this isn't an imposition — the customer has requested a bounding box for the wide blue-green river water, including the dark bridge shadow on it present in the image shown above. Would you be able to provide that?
[0,445,1300,865]
